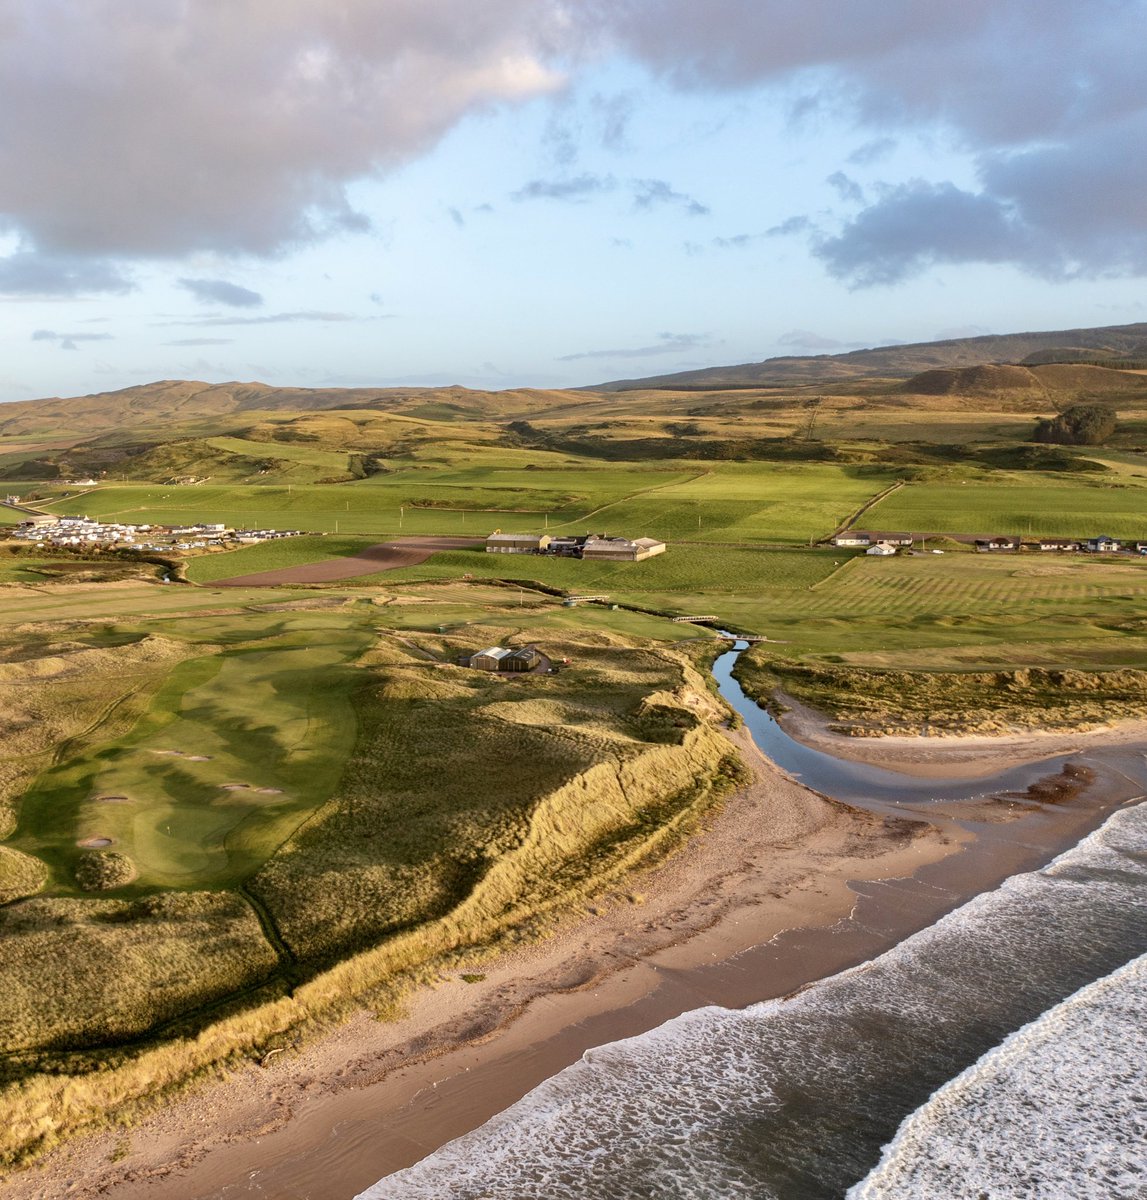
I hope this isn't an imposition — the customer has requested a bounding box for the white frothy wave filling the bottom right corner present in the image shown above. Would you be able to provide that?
[848,955,1147,1200]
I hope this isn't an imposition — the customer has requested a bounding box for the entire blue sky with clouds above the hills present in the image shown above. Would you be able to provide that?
[0,0,1147,401]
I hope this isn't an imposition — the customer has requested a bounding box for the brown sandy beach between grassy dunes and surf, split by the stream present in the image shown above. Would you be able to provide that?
[6,718,1143,1200]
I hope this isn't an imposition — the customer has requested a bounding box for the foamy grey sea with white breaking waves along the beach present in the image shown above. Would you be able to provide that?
[359,803,1147,1200]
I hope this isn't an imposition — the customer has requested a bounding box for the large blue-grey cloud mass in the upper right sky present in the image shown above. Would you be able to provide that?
[587,0,1147,286]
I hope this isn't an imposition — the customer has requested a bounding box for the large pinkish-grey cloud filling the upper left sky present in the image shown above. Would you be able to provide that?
[0,0,563,259]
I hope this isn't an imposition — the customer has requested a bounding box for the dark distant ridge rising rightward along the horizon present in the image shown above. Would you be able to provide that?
[584,323,1147,391]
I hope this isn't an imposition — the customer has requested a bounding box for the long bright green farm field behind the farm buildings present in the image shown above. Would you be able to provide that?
[31,463,894,545]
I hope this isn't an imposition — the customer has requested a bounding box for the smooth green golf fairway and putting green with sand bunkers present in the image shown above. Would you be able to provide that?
[12,613,371,887]
